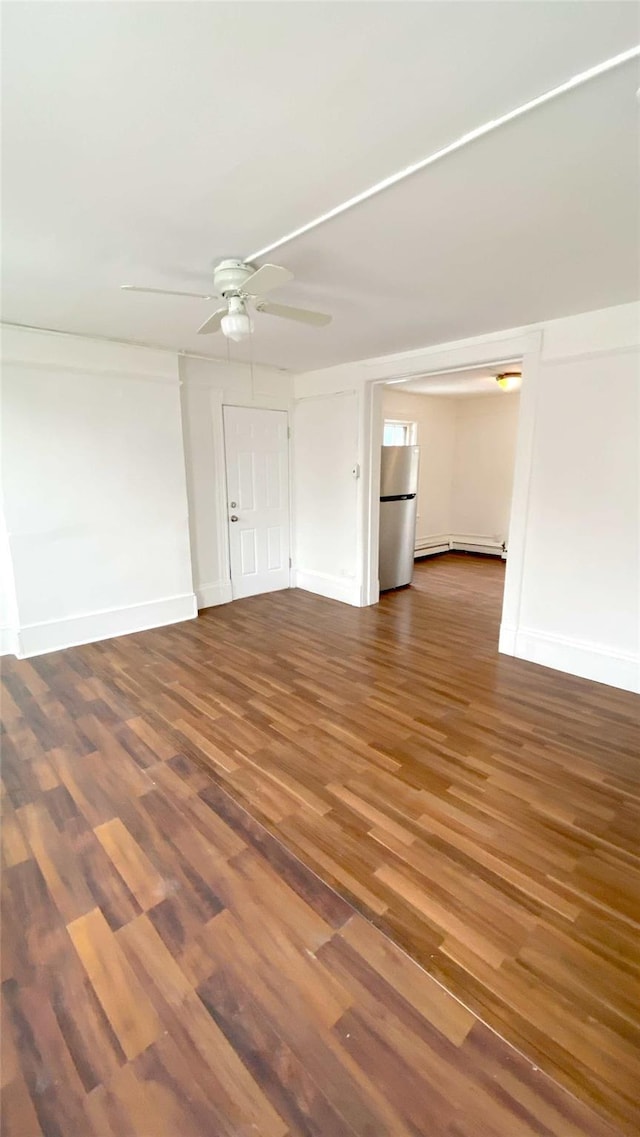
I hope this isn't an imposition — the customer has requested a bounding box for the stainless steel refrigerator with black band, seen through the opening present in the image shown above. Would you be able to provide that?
[380,446,419,591]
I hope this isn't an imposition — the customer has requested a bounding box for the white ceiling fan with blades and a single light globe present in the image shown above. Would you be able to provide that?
[120,259,331,341]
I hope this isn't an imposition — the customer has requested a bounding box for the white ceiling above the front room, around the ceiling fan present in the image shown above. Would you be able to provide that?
[2,0,640,370]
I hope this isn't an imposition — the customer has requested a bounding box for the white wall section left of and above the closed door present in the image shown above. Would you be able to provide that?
[180,356,292,608]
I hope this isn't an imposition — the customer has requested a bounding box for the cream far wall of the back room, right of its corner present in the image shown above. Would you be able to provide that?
[450,392,520,548]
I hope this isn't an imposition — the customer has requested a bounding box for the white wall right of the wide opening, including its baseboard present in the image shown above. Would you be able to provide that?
[501,317,640,690]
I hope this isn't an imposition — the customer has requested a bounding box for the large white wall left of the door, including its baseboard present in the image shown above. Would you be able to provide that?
[2,329,196,655]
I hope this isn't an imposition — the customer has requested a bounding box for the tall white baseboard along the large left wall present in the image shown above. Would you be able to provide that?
[16,592,198,659]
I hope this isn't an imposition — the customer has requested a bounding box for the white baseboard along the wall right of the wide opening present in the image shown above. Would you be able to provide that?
[499,624,640,694]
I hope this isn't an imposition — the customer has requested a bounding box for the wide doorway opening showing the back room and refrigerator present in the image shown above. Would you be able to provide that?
[379,359,522,639]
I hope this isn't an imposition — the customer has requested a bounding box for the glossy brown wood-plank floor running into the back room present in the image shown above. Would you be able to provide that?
[2,556,640,1137]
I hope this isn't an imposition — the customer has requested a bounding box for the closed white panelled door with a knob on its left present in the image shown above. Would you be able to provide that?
[224,407,289,600]
